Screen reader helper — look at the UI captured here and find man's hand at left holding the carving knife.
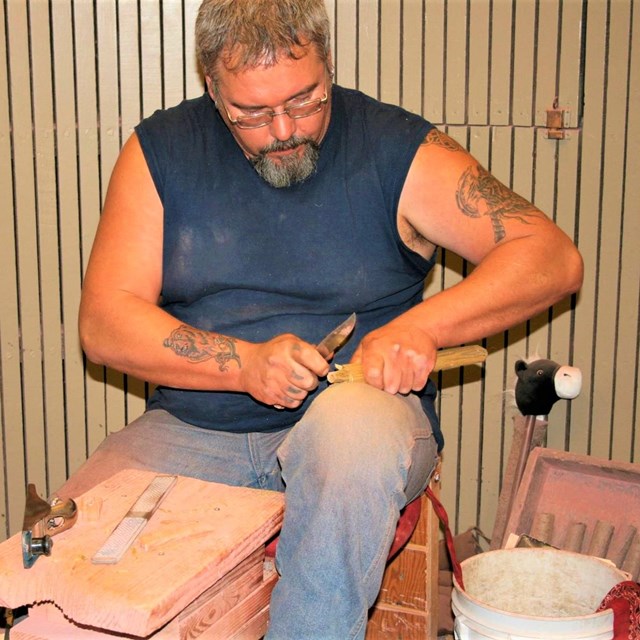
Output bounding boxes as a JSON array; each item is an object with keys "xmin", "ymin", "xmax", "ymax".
[{"xmin": 240, "ymin": 334, "xmax": 329, "ymax": 409}]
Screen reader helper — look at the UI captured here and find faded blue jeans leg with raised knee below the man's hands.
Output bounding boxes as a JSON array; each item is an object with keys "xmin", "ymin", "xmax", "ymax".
[{"xmin": 267, "ymin": 383, "xmax": 437, "ymax": 640}]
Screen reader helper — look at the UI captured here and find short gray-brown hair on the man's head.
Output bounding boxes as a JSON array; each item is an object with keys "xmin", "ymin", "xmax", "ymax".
[{"xmin": 195, "ymin": 0, "xmax": 331, "ymax": 77}]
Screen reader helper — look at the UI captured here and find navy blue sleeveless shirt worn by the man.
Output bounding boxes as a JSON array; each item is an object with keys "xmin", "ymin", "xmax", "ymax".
[{"xmin": 136, "ymin": 86, "xmax": 443, "ymax": 447}]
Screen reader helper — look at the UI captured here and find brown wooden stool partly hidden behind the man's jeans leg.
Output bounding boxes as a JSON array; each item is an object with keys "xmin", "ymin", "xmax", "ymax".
[{"xmin": 366, "ymin": 471, "xmax": 440, "ymax": 640}]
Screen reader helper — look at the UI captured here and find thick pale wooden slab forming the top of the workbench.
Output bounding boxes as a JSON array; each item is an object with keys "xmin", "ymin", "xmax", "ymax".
[{"xmin": 0, "ymin": 470, "xmax": 284, "ymax": 637}]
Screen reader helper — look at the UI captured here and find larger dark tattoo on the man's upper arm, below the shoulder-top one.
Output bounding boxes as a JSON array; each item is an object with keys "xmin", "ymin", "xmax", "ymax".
[{"xmin": 456, "ymin": 164, "xmax": 541, "ymax": 243}]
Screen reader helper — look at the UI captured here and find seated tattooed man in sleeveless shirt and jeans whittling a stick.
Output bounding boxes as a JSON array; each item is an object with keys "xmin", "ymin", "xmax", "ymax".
[{"xmin": 70, "ymin": 0, "xmax": 582, "ymax": 640}]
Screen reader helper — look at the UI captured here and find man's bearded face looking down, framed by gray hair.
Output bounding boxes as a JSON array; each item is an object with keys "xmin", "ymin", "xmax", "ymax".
[{"xmin": 207, "ymin": 47, "xmax": 331, "ymax": 187}]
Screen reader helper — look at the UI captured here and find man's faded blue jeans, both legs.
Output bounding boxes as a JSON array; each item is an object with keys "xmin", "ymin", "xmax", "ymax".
[{"xmin": 58, "ymin": 383, "xmax": 437, "ymax": 640}]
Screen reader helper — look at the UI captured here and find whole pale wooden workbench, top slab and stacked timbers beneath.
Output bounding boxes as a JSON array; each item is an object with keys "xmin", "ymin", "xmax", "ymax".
[{"xmin": 0, "ymin": 470, "xmax": 284, "ymax": 640}]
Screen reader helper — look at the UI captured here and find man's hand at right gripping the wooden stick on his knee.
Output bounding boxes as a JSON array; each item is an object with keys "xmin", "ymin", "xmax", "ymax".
[{"xmin": 351, "ymin": 318, "xmax": 437, "ymax": 393}]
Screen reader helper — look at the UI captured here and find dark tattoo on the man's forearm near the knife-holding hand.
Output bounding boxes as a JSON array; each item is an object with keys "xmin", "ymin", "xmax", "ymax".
[{"xmin": 162, "ymin": 324, "xmax": 242, "ymax": 371}]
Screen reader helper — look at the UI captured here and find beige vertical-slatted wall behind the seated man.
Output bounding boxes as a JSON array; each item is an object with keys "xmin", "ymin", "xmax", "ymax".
[{"xmin": 0, "ymin": 0, "xmax": 640, "ymax": 538}]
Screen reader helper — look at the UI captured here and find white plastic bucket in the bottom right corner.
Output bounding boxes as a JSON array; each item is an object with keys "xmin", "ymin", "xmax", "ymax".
[{"xmin": 452, "ymin": 549, "xmax": 628, "ymax": 640}]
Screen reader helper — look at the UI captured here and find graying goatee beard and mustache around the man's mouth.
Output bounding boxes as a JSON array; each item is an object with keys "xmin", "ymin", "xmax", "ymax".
[{"xmin": 251, "ymin": 136, "xmax": 320, "ymax": 189}]
